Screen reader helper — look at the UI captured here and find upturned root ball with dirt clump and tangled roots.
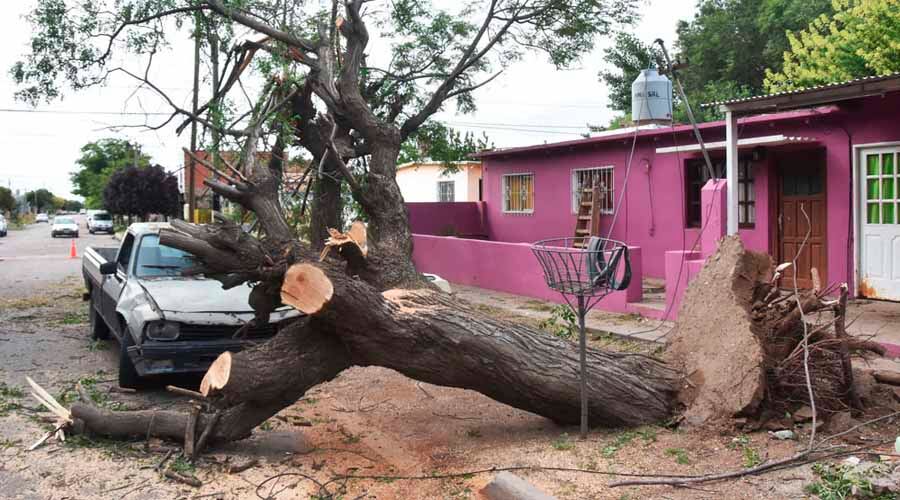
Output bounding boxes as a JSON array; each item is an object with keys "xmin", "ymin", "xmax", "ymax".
[{"xmin": 668, "ymin": 236, "xmax": 884, "ymax": 426}]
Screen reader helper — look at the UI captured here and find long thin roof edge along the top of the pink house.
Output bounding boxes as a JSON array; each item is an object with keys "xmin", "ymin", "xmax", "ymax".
[{"xmin": 472, "ymin": 106, "xmax": 838, "ymax": 159}]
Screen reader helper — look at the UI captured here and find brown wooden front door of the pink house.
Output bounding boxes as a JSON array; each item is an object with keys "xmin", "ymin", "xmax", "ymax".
[{"xmin": 776, "ymin": 153, "xmax": 828, "ymax": 288}]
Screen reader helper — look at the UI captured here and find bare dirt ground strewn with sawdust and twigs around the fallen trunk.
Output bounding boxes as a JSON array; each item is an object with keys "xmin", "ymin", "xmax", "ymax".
[{"xmin": 0, "ymin": 280, "xmax": 898, "ymax": 500}]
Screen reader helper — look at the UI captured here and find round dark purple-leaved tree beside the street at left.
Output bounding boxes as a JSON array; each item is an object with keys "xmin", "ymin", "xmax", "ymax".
[{"xmin": 103, "ymin": 165, "xmax": 181, "ymax": 219}]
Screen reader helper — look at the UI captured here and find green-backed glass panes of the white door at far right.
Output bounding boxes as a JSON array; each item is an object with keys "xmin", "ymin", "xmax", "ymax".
[{"xmin": 866, "ymin": 151, "xmax": 900, "ymax": 224}]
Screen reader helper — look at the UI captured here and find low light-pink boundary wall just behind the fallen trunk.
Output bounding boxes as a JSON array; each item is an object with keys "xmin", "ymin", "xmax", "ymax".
[{"xmin": 413, "ymin": 234, "xmax": 663, "ymax": 318}]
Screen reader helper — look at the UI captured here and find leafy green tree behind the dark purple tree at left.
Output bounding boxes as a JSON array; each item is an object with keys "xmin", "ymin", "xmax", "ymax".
[{"xmin": 71, "ymin": 139, "xmax": 150, "ymax": 209}]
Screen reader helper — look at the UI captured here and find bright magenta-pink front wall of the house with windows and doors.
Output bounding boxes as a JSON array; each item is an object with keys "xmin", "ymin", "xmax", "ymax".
[{"xmin": 482, "ymin": 93, "xmax": 900, "ymax": 290}]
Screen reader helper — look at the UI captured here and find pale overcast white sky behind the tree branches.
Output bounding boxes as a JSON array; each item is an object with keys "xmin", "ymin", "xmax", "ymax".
[{"xmin": 0, "ymin": 0, "xmax": 696, "ymax": 199}]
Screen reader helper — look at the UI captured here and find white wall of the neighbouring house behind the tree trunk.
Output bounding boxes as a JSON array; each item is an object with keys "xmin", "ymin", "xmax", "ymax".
[{"xmin": 397, "ymin": 162, "xmax": 481, "ymax": 203}]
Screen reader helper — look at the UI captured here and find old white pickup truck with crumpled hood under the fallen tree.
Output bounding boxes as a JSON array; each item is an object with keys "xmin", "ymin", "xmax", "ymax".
[{"xmin": 82, "ymin": 223, "xmax": 301, "ymax": 388}]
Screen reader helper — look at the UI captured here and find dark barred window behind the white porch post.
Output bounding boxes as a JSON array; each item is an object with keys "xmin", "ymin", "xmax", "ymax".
[{"xmin": 685, "ymin": 158, "xmax": 756, "ymax": 228}]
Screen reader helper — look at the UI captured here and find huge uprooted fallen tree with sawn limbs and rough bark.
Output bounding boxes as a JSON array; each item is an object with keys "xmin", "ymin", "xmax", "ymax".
[{"xmin": 20, "ymin": 0, "xmax": 896, "ymax": 453}]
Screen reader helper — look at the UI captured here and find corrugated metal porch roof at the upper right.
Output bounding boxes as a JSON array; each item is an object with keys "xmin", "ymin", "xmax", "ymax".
[{"xmin": 701, "ymin": 72, "xmax": 900, "ymax": 113}]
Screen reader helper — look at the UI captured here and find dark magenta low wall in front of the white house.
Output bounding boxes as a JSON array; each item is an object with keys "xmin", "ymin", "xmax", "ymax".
[{"xmin": 406, "ymin": 201, "xmax": 487, "ymax": 237}]
